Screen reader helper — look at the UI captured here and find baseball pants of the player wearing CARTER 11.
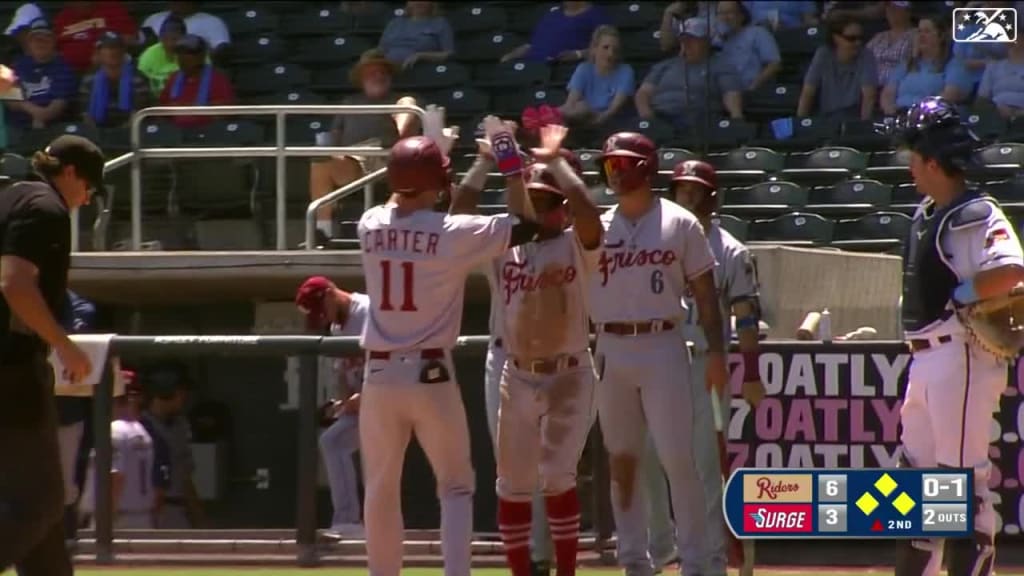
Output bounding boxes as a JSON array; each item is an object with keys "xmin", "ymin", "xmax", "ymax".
[{"xmin": 359, "ymin": 351, "xmax": 475, "ymax": 576}]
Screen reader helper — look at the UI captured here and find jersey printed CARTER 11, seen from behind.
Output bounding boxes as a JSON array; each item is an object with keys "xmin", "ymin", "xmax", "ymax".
[{"xmin": 358, "ymin": 204, "xmax": 518, "ymax": 352}]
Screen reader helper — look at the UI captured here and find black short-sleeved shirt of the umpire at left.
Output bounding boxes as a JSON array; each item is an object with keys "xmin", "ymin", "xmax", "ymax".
[{"xmin": 0, "ymin": 179, "xmax": 71, "ymax": 362}]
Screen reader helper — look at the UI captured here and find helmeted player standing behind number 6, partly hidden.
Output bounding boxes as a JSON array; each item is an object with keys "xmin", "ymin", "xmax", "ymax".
[{"xmin": 672, "ymin": 160, "xmax": 765, "ymax": 576}]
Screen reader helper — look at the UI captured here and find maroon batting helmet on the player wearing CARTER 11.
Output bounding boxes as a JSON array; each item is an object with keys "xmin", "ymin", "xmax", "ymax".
[{"xmin": 387, "ymin": 136, "xmax": 451, "ymax": 196}]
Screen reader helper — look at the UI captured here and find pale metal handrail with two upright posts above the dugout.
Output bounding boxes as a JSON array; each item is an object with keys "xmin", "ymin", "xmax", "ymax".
[{"xmin": 130, "ymin": 105, "xmax": 426, "ymax": 250}]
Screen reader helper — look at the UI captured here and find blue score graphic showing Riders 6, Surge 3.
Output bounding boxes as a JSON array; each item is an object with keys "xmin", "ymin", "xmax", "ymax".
[{"xmin": 723, "ymin": 468, "xmax": 974, "ymax": 539}]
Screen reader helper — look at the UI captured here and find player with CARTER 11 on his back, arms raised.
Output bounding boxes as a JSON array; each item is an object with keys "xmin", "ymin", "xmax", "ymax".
[{"xmin": 358, "ymin": 131, "xmax": 542, "ymax": 576}]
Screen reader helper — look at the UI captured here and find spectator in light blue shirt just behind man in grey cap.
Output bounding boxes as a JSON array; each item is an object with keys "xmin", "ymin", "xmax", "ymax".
[{"xmin": 718, "ymin": 1, "xmax": 782, "ymax": 90}]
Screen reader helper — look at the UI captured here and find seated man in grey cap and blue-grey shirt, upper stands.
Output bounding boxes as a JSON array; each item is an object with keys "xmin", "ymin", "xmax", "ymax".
[{"xmin": 636, "ymin": 17, "xmax": 743, "ymax": 127}]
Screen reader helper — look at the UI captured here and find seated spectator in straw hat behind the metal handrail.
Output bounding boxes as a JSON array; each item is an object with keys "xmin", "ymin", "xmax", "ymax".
[{"xmin": 309, "ymin": 48, "xmax": 418, "ymax": 245}]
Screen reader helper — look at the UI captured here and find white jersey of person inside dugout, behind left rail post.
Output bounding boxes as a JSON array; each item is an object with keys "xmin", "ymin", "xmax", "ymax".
[{"xmin": 82, "ymin": 420, "xmax": 157, "ymax": 513}]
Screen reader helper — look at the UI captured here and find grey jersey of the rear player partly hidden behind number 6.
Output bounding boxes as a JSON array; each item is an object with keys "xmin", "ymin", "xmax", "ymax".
[{"xmin": 683, "ymin": 222, "xmax": 758, "ymax": 351}]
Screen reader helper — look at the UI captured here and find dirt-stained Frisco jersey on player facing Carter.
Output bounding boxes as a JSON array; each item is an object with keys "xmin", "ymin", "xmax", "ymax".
[{"xmin": 490, "ymin": 229, "xmax": 600, "ymax": 359}]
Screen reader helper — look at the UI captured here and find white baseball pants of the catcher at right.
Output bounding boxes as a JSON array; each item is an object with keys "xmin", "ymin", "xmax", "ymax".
[{"xmin": 900, "ymin": 335, "xmax": 1008, "ymax": 576}]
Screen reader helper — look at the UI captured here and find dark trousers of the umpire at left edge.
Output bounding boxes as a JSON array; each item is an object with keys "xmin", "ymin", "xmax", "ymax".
[{"xmin": 0, "ymin": 356, "xmax": 72, "ymax": 576}]
